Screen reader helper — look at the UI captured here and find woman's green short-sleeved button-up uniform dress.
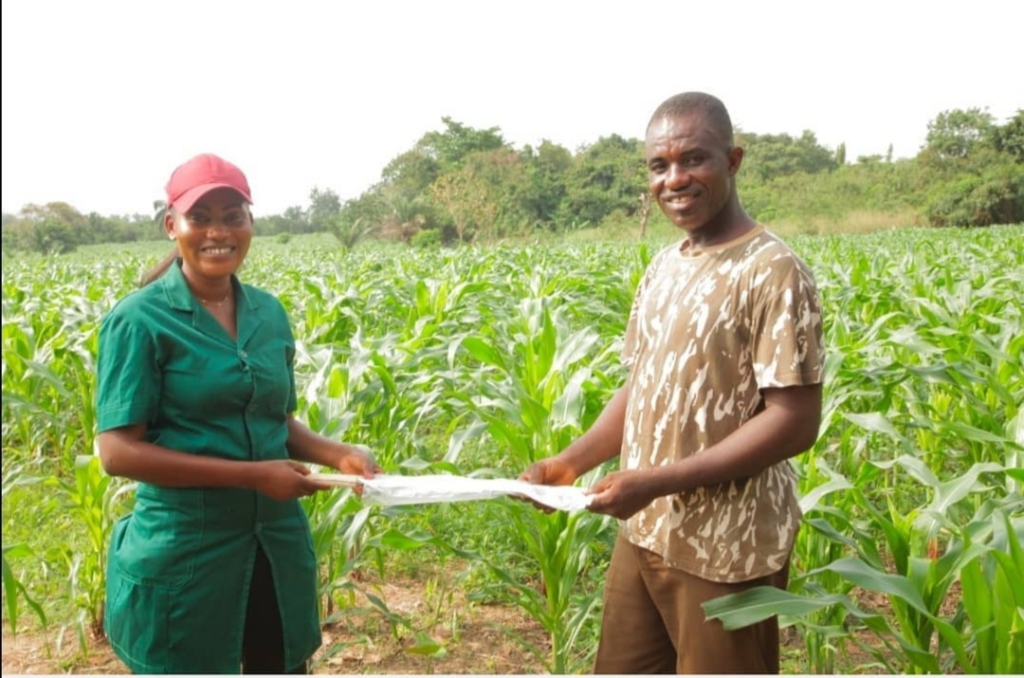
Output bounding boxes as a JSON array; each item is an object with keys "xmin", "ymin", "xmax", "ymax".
[{"xmin": 97, "ymin": 262, "xmax": 322, "ymax": 674}]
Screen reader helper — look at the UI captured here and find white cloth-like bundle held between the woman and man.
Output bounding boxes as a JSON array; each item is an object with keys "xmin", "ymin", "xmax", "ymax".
[{"xmin": 311, "ymin": 473, "xmax": 590, "ymax": 512}]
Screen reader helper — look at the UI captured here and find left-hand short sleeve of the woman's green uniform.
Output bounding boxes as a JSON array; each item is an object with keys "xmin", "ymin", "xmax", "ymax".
[{"xmin": 96, "ymin": 308, "xmax": 161, "ymax": 432}]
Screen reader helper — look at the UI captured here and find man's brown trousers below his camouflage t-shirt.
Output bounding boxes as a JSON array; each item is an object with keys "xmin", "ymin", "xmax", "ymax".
[{"xmin": 594, "ymin": 536, "xmax": 788, "ymax": 674}]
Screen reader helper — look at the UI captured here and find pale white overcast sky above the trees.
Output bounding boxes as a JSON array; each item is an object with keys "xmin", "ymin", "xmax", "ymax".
[{"xmin": 2, "ymin": 0, "xmax": 1024, "ymax": 216}]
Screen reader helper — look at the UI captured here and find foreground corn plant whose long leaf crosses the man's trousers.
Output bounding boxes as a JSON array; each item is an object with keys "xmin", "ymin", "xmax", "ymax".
[{"xmin": 705, "ymin": 458, "xmax": 1024, "ymax": 673}]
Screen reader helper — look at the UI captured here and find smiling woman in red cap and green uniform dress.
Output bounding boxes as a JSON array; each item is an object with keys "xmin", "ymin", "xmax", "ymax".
[{"xmin": 97, "ymin": 155, "xmax": 380, "ymax": 673}]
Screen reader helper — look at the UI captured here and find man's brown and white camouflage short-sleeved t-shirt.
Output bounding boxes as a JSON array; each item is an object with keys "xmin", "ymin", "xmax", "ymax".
[{"xmin": 621, "ymin": 226, "xmax": 824, "ymax": 582}]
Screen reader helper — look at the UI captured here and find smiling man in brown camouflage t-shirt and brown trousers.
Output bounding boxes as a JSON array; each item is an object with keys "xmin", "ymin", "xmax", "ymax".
[{"xmin": 522, "ymin": 92, "xmax": 823, "ymax": 674}]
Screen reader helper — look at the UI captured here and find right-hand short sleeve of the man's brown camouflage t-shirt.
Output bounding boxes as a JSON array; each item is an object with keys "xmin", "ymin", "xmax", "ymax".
[{"xmin": 752, "ymin": 258, "xmax": 824, "ymax": 388}]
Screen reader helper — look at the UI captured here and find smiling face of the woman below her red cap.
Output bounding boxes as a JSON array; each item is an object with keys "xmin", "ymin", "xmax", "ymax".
[{"xmin": 164, "ymin": 188, "xmax": 253, "ymax": 283}]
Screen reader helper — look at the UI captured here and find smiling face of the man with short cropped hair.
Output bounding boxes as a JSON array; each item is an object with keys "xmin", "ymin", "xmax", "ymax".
[{"xmin": 645, "ymin": 113, "xmax": 743, "ymax": 234}]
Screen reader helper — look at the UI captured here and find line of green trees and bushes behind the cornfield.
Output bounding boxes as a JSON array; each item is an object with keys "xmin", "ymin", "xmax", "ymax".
[{"xmin": 3, "ymin": 109, "xmax": 1024, "ymax": 253}]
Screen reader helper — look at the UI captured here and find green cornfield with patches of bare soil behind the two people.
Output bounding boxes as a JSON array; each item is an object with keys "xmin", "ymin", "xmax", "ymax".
[{"xmin": 2, "ymin": 225, "xmax": 1024, "ymax": 674}]
